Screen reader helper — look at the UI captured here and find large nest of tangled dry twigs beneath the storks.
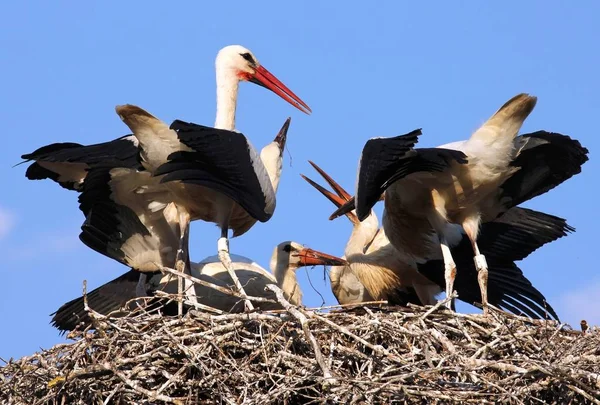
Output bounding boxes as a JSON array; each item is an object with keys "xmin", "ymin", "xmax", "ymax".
[{"xmin": 0, "ymin": 287, "xmax": 600, "ymax": 405}]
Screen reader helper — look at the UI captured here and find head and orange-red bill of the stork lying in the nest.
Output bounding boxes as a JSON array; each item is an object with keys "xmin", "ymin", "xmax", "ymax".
[{"xmin": 271, "ymin": 241, "xmax": 348, "ymax": 270}]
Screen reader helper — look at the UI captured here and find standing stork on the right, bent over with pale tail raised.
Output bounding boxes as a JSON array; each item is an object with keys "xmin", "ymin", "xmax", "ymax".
[{"xmin": 332, "ymin": 94, "xmax": 587, "ymax": 311}]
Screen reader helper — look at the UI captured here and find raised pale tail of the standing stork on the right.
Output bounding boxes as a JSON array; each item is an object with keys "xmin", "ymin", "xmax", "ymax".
[{"xmin": 471, "ymin": 93, "xmax": 537, "ymax": 143}]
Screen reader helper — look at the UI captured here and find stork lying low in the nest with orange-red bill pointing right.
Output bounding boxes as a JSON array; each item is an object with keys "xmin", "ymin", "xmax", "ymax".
[{"xmin": 52, "ymin": 241, "xmax": 346, "ymax": 331}]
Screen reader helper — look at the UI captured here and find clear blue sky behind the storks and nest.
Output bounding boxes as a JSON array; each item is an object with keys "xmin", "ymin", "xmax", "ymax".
[{"xmin": 0, "ymin": 0, "xmax": 600, "ymax": 359}]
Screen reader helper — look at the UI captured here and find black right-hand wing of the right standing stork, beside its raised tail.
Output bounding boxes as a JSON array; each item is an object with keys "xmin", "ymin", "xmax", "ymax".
[{"xmin": 501, "ymin": 131, "xmax": 588, "ymax": 207}]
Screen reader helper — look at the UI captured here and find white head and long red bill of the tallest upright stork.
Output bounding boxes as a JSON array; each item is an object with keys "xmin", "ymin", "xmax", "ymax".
[{"xmin": 215, "ymin": 45, "xmax": 312, "ymax": 114}]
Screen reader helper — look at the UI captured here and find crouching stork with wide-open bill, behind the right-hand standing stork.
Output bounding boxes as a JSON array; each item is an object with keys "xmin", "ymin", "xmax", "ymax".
[{"xmin": 303, "ymin": 162, "xmax": 573, "ymax": 318}]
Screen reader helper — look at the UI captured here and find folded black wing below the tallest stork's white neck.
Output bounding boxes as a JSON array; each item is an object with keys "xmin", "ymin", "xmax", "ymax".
[{"xmin": 155, "ymin": 120, "xmax": 274, "ymax": 222}]
